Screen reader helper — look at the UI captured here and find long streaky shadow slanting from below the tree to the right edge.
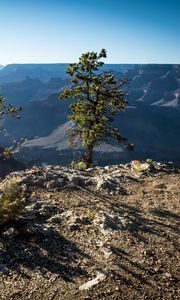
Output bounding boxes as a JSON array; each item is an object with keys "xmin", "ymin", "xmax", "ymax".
[{"xmin": 83, "ymin": 189, "xmax": 180, "ymax": 243}]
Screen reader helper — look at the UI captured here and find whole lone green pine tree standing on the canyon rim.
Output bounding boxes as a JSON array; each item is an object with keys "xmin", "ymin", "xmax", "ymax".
[{"xmin": 60, "ymin": 49, "xmax": 133, "ymax": 167}]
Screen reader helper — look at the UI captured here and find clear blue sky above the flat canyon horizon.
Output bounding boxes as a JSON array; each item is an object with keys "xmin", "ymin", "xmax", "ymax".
[{"xmin": 0, "ymin": 0, "xmax": 180, "ymax": 65}]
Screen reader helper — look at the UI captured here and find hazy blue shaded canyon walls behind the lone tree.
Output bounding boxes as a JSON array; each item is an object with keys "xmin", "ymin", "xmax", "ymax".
[{"xmin": 0, "ymin": 64, "xmax": 180, "ymax": 165}]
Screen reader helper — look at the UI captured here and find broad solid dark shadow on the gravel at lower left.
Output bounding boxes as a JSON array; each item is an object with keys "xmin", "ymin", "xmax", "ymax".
[{"xmin": 0, "ymin": 197, "xmax": 89, "ymax": 282}]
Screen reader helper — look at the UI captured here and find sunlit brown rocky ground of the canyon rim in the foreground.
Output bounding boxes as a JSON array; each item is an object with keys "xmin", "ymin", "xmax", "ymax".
[{"xmin": 0, "ymin": 162, "xmax": 180, "ymax": 300}]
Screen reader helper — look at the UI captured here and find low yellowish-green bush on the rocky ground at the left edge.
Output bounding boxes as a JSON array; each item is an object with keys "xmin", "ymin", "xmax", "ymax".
[{"xmin": 0, "ymin": 179, "xmax": 25, "ymax": 224}]
